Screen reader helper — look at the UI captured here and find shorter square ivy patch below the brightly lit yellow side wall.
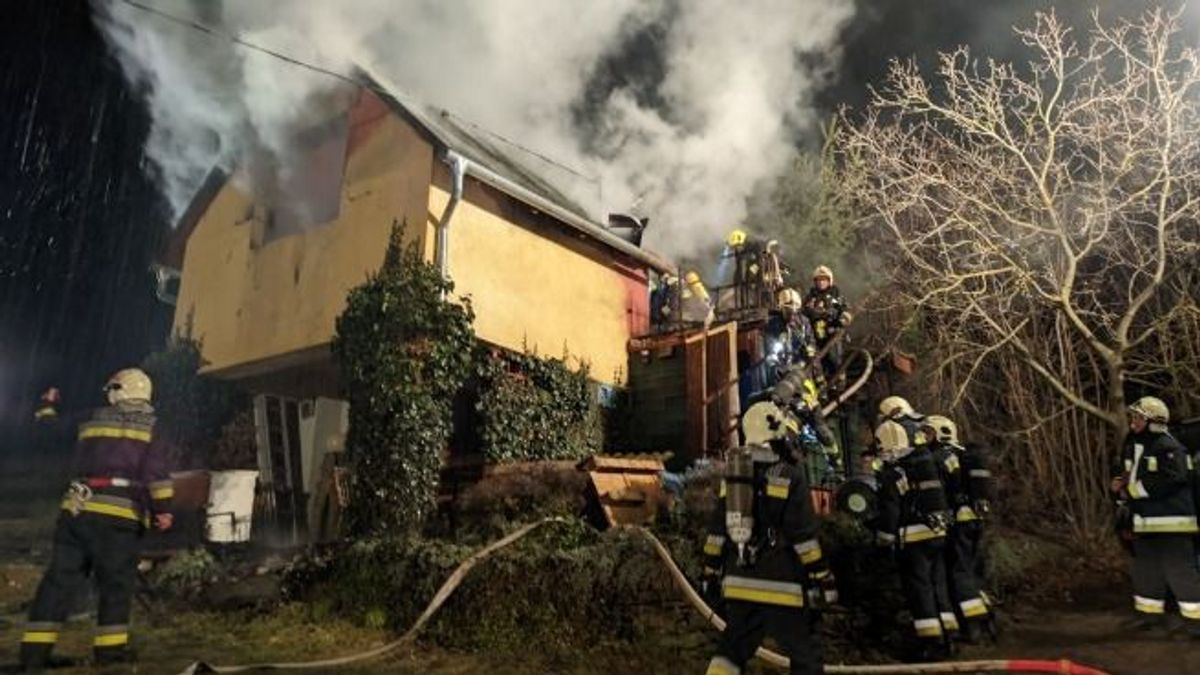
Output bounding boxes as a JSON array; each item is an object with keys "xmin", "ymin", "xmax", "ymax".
[{"xmin": 475, "ymin": 352, "xmax": 604, "ymax": 462}]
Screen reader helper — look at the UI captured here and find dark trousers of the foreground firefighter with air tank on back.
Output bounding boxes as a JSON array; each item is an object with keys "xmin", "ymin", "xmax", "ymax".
[{"xmin": 708, "ymin": 601, "xmax": 824, "ymax": 675}]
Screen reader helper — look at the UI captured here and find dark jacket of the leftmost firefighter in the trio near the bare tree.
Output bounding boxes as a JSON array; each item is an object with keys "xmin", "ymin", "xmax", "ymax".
[{"xmin": 875, "ymin": 447, "xmax": 949, "ymax": 546}]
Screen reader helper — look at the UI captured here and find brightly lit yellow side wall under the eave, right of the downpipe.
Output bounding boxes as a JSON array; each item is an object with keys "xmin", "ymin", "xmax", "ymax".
[{"xmin": 428, "ymin": 178, "xmax": 631, "ymax": 384}]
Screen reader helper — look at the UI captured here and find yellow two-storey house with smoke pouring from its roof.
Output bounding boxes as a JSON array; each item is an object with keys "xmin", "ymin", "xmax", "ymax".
[{"xmin": 161, "ymin": 72, "xmax": 671, "ymax": 535}]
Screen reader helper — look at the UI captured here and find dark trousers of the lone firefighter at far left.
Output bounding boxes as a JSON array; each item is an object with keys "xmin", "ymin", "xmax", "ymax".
[{"xmin": 20, "ymin": 513, "xmax": 142, "ymax": 668}]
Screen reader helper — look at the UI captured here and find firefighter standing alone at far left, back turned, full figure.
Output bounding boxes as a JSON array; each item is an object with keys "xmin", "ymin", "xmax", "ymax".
[{"xmin": 20, "ymin": 369, "xmax": 174, "ymax": 671}]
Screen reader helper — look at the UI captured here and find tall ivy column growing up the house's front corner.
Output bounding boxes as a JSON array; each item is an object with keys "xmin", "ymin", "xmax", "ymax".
[{"xmin": 332, "ymin": 227, "xmax": 475, "ymax": 534}]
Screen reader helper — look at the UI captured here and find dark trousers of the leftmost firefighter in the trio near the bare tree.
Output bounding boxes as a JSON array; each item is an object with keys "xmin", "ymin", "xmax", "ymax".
[{"xmin": 900, "ymin": 538, "xmax": 959, "ymax": 643}]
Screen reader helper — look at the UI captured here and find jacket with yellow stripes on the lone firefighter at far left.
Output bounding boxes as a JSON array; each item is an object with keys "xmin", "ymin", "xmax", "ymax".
[{"xmin": 62, "ymin": 401, "xmax": 175, "ymax": 525}]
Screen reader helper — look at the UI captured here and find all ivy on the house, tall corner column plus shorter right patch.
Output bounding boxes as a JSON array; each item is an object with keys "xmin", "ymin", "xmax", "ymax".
[{"xmin": 332, "ymin": 223, "xmax": 605, "ymax": 534}]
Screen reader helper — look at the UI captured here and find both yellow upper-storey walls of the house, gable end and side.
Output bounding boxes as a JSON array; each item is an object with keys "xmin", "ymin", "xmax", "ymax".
[{"xmin": 175, "ymin": 97, "xmax": 644, "ymax": 386}]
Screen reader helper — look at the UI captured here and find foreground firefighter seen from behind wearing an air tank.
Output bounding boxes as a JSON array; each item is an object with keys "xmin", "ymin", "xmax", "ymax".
[{"xmin": 702, "ymin": 423, "xmax": 838, "ymax": 675}]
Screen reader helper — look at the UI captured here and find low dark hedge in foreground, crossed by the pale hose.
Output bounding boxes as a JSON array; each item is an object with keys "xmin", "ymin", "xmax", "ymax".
[{"xmin": 289, "ymin": 520, "xmax": 701, "ymax": 656}]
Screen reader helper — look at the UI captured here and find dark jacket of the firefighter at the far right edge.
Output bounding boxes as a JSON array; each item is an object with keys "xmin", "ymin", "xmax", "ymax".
[{"xmin": 1121, "ymin": 430, "xmax": 1200, "ymax": 534}]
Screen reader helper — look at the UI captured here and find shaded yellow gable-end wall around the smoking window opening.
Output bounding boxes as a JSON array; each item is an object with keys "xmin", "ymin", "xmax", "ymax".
[{"xmin": 174, "ymin": 110, "xmax": 433, "ymax": 371}]
